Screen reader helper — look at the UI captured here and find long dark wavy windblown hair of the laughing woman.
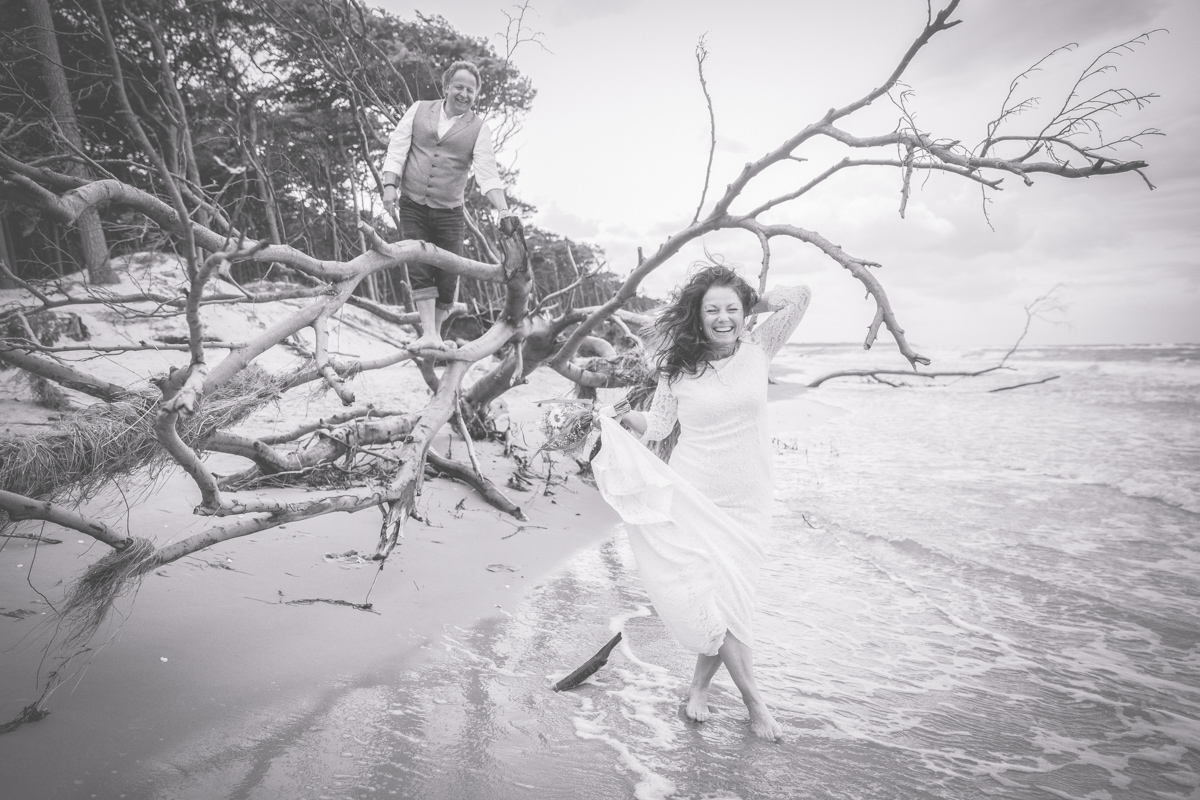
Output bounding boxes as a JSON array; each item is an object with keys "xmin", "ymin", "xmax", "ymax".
[{"xmin": 654, "ymin": 261, "xmax": 758, "ymax": 381}]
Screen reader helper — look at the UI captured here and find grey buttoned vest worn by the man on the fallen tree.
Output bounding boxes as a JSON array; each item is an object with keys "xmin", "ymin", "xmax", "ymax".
[{"xmin": 400, "ymin": 100, "xmax": 484, "ymax": 209}]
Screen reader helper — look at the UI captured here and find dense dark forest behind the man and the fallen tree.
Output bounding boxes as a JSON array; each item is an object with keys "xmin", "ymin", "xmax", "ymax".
[{"xmin": 0, "ymin": 0, "xmax": 638, "ymax": 318}]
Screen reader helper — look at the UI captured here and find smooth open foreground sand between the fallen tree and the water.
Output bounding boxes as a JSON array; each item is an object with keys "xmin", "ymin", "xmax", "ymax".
[{"xmin": 0, "ymin": 386, "xmax": 617, "ymax": 798}]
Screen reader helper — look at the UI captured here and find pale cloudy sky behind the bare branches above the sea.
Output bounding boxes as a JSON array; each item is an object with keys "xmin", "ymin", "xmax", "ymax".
[{"xmin": 382, "ymin": 0, "xmax": 1200, "ymax": 347}]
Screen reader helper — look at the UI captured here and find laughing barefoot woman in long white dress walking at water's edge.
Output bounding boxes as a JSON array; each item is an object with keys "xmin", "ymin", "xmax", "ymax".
[{"xmin": 593, "ymin": 265, "xmax": 810, "ymax": 740}]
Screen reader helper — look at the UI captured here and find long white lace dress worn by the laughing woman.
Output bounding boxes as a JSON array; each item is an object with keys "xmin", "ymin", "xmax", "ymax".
[{"xmin": 592, "ymin": 287, "xmax": 811, "ymax": 655}]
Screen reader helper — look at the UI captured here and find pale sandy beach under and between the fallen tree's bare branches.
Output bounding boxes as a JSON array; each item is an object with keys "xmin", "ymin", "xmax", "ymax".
[{"xmin": 0, "ymin": 263, "xmax": 616, "ymax": 798}]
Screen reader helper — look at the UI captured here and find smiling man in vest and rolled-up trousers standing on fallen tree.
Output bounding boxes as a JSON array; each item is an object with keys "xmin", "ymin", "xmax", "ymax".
[{"xmin": 383, "ymin": 61, "xmax": 514, "ymax": 350}]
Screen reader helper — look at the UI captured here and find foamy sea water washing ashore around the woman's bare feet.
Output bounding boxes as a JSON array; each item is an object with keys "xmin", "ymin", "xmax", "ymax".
[{"xmin": 218, "ymin": 345, "xmax": 1200, "ymax": 800}]
